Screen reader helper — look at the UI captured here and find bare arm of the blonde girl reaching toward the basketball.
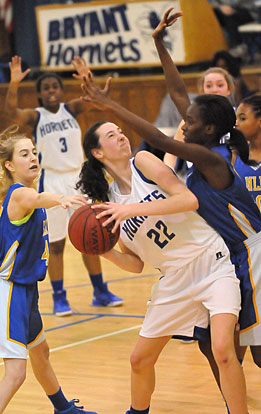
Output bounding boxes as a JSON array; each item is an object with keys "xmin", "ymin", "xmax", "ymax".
[{"xmin": 8, "ymin": 187, "xmax": 87, "ymax": 220}]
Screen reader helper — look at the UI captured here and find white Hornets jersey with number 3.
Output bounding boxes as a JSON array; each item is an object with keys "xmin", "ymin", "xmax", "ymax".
[{"xmin": 33, "ymin": 103, "xmax": 83, "ymax": 172}]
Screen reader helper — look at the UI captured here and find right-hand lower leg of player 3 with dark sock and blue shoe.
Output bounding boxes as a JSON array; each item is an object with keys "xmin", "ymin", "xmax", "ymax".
[{"xmin": 82, "ymin": 254, "xmax": 123, "ymax": 306}]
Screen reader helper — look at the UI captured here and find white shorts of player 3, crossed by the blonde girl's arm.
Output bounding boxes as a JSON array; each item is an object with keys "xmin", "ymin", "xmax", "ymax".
[{"xmin": 39, "ymin": 170, "xmax": 81, "ymax": 243}]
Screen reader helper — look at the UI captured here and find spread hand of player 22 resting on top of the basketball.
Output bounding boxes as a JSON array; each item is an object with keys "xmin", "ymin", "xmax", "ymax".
[{"xmin": 92, "ymin": 201, "xmax": 132, "ymax": 233}]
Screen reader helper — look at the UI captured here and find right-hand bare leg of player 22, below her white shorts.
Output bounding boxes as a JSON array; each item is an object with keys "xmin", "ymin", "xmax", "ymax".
[{"xmin": 210, "ymin": 313, "xmax": 247, "ymax": 414}]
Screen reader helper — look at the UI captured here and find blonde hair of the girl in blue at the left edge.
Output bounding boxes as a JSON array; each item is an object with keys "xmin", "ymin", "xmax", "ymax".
[{"xmin": 0, "ymin": 125, "xmax": 30, "ymax": 203}]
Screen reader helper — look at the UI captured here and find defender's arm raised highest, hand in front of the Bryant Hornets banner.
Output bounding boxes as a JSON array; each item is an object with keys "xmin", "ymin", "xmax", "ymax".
[{"xmin": 152, "ymin": 7, "xmax": 190, "ymax": 119}]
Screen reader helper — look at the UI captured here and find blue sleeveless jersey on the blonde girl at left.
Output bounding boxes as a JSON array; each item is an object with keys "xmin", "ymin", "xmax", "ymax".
[{"xmin": 0, "ymin": 184, "xmax": 49, "ymax": 284}]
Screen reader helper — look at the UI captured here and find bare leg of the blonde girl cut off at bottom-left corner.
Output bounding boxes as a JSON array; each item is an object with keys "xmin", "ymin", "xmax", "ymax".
[{"xmin": 0, "ymin": 358, "xmax": 26, "ymax": 413}]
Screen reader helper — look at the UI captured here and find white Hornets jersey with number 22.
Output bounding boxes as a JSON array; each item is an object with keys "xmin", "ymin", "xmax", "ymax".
[{"xmin": 109, "ymin": 159, "xmax": 221, "ymax": 275}]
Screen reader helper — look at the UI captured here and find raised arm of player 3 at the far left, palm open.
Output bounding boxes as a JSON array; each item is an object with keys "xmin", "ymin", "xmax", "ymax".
[{"xmin": 4, "ymin": 56, "xmax": 37, "ymax": 128}]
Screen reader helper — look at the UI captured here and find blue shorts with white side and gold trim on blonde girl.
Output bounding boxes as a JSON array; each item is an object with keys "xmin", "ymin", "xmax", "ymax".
[{"xmin": 0, "ymin": 278, "xmax": 45, "ymax": 359}]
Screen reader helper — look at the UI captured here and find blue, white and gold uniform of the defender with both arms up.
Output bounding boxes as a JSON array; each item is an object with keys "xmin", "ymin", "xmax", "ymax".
[{"xmin": 187, "ymin": 144, "xmax": 261, "ymax": 332}]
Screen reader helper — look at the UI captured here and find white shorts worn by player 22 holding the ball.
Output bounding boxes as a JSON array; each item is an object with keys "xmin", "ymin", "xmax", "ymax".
[{"xmin": 140, "ymin": 239, "xmax": 241, "ymax": 339}]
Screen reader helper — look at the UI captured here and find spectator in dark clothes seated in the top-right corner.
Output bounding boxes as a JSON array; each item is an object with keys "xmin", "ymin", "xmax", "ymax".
[{"xmin": 208, "ymin": 0, "xmax": 258, "ymax": 57}]
